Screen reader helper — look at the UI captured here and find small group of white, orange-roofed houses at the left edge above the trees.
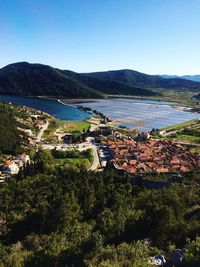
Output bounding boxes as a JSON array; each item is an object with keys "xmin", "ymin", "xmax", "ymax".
[{"xmin": 0, "ymin": 153, "xmax": 30, "ymax": 181}]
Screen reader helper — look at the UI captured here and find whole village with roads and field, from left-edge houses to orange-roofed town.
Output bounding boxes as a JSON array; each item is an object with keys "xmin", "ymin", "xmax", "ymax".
[{"xmin": 0, "ymin": 102, "xmax": 200, "ymax": 182}]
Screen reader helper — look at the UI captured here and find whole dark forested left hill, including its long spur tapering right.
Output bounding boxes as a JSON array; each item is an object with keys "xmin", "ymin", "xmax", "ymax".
[{"xmin": 0, "ymin": 62, "xmax": 156, "ymax": 98}]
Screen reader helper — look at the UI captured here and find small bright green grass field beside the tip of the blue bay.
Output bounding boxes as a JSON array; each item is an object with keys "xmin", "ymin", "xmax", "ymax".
[{"xmin": 63, "ymin": 121, "xmax": 90, "ymax": 133}]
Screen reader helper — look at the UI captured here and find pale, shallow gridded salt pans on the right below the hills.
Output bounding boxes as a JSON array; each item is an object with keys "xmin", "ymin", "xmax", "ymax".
[{"xmin": 81, "ymin": 98, "xmax": 200, "ymax": 131}]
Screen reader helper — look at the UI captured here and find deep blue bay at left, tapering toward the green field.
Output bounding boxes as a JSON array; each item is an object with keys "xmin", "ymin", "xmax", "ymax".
[{"xmin": 0, "ymin": 95, "xmax": 91, "ymax": 120}]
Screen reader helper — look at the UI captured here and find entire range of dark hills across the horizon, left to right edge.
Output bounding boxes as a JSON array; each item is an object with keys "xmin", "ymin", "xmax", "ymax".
[{"xmin": 0, "ymin": 62, "xmax": 200, "ymax": 98}]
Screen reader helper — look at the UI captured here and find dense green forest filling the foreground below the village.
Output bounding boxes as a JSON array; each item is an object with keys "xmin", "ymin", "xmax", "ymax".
[{"xmin": 0, "ymin": 157, "xmax": 200, "ymax": 267}]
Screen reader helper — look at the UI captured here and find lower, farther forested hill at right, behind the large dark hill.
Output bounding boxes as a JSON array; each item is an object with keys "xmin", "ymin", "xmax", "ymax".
[{"xmin": 84, "ymin": 69, "xmax": 200, "ymax": 91}]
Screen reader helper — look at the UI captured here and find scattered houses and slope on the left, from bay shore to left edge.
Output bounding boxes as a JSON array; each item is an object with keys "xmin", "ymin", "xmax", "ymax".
[{"xmin": 0, "ymin": 103, "xmax": 50, "ymax": 183}]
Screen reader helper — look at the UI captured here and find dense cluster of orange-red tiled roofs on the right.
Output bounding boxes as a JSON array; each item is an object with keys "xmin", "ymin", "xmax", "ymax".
[{"xmin": 104, "ymin": 139, "xmax": 200, "ymax": 173}]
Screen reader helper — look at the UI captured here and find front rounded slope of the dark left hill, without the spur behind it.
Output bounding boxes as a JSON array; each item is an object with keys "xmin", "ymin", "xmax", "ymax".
[{"xmin": 0, "ymin": 62, "xmax": 102, "ymax": 97}]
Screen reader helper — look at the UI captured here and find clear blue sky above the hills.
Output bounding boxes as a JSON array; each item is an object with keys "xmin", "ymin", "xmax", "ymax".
[{"xmin": 0, "ymin": 0, "xmax": 200, "ymax": 75}]
